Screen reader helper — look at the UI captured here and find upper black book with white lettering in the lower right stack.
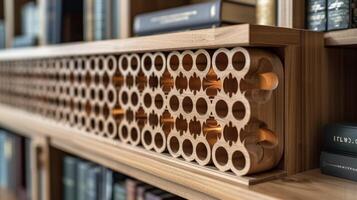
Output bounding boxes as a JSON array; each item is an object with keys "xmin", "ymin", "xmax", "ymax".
[{"xmin": 323, "ymin": 123, "xmax": 357, "ymax": 155}]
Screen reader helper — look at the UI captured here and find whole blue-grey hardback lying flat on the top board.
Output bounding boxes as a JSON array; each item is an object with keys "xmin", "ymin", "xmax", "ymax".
[{"xmin": 134, "ymin": 1, "xmax": 255, "ymax": 35}]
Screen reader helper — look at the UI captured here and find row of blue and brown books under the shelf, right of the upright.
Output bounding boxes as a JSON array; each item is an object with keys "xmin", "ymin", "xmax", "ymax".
[{"xmin": 62, "ymin": 155, "xmax": 182, "ymax": 200}]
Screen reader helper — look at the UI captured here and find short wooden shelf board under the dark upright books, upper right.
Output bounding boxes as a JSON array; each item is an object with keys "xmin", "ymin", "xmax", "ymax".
[{"xmin": 324, "ymin": 28, "xmax": 357, "ymax": 47}]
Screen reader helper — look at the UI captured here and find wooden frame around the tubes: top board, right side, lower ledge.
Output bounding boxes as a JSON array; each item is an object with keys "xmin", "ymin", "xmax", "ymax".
[{"xmin": 0, "ymin": 22, "xmax": 342, "ymax": 199}]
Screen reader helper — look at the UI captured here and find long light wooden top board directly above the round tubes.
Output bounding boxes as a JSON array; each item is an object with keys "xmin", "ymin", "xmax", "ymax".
[{"xmin": 0, "ymin": 24, "xmax": 300, "ymax": 60}]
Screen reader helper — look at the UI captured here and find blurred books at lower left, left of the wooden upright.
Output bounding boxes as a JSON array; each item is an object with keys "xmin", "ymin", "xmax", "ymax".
[{"xmin": 0, "ymin": 129, "xmax": 31, "ymax": 199}]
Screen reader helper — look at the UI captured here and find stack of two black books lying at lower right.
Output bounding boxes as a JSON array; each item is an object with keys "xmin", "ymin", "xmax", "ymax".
[{"xmin": 320, "ymin": 124, "xmax": 357, "ymax": 181}]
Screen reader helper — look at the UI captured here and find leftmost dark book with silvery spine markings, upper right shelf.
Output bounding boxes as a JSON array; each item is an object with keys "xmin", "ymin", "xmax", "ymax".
[{"xmin": 307, "ymin": 0, "xmax": 327, "ymax": 31}]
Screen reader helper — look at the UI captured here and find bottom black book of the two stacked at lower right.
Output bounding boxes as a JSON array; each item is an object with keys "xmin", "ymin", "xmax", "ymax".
[{"xmin": 320, "ymin": 151, "xmax": 357, "ymax": 181}]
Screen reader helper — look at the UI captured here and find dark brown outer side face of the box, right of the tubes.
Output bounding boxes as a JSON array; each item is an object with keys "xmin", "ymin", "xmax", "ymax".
[{"xmin": 301, "ymin": 32, "xmax": 329, "ymax": 170}]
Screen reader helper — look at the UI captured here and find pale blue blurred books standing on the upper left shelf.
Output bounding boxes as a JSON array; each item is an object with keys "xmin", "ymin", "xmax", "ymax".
[{"xmin": 12, "ymin": 1, "xmax": 39, "ymax": 47}]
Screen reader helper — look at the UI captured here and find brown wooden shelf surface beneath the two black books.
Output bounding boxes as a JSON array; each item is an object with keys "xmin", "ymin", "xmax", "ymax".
[{"xmin": 250, "ymin": 169, "xmax": 357, "ymax": 200}]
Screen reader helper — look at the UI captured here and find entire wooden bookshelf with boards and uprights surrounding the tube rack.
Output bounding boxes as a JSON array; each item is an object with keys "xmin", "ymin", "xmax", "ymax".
[{"xmin": 0, "ymin": 0, "xmax": 357, "ymax": 200}]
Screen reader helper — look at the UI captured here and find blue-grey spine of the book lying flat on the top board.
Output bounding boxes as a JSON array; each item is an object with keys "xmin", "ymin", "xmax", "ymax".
[{"xmin": 134, "ymin": 1, "xmax": 222, "ymax": 35}]
